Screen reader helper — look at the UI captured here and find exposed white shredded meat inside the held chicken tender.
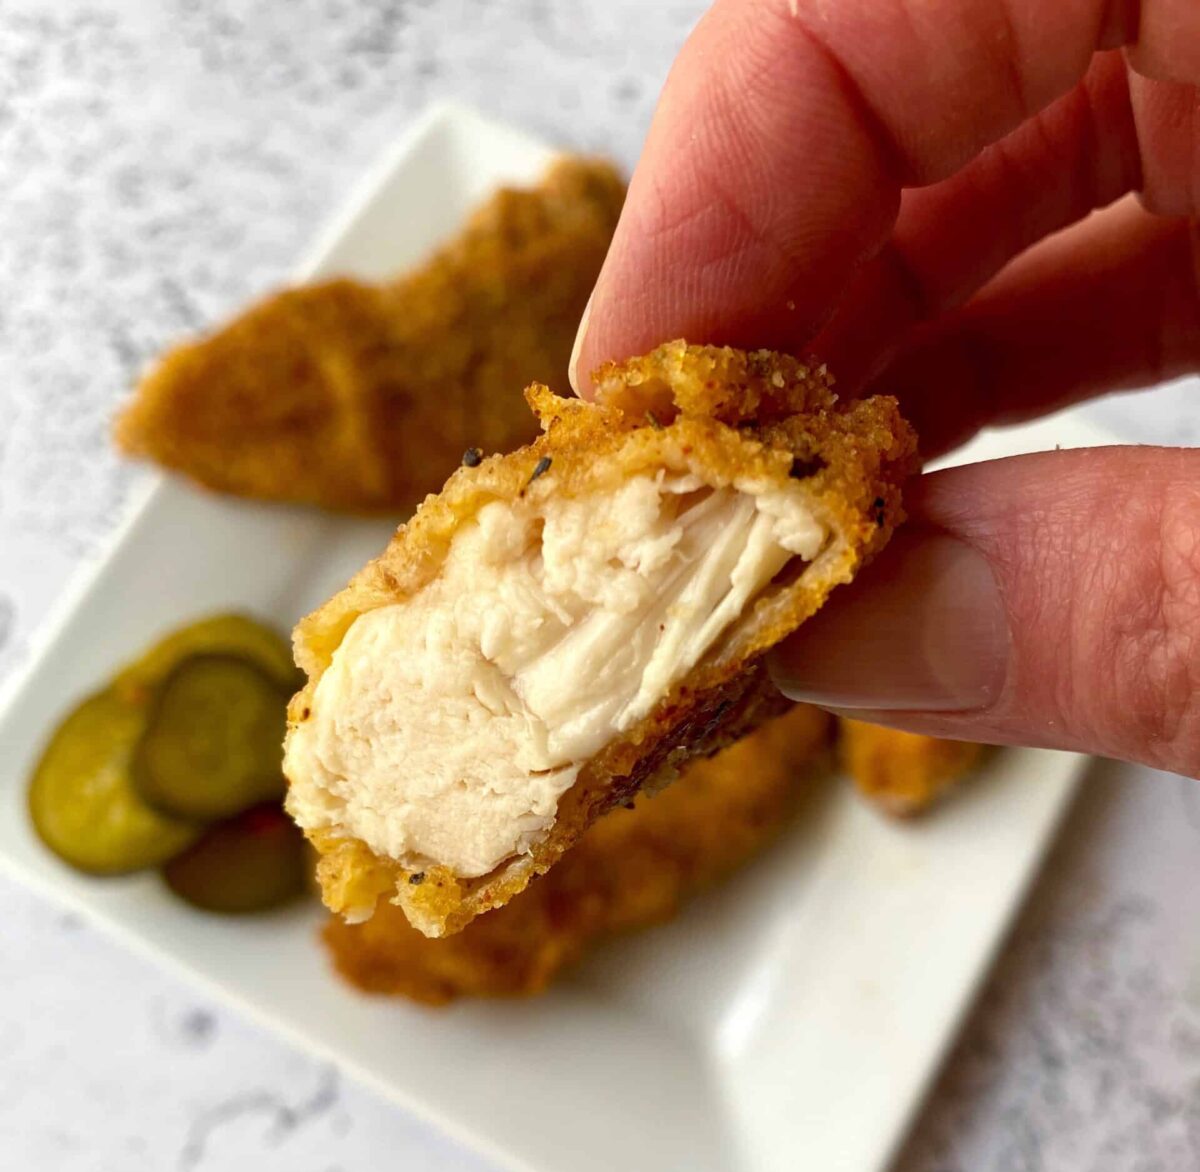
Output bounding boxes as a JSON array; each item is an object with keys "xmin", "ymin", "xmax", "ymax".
[{"xmin": 290, "ymin": 473, "xmax": 827, "ymax": 877}]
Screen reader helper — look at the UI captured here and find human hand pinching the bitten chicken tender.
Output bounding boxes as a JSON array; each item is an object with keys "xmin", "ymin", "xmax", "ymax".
[{"xmin": 572, "ymin": 0, "xmax": 1200, "ymax": 775}]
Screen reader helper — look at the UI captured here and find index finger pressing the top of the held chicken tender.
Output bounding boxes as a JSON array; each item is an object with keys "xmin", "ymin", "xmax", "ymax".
[{"xmin": 571, "ymin": 0, "xmax": 1132, "ymax": 390}]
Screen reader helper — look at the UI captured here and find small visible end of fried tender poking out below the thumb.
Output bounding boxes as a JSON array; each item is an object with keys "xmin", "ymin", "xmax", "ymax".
[{"xmin": 839, "ymin": 719, "xmax": 983, "ymax": 817}]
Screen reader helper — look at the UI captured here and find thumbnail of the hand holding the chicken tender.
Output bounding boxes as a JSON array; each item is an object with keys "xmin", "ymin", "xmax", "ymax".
[{"xmin": 772, "ymin": 534, "xmax": 1009, "ymax": 713}]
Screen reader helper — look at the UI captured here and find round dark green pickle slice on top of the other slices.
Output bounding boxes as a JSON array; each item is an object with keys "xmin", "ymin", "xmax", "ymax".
[{"xmin": 133, "ymin": 655, "xmax": 288, "ymax": 822}]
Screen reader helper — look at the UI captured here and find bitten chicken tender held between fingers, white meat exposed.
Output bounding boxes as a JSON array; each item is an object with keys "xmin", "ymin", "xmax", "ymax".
[{"xmin": 284, "ymin": 342, "xmax": 916, "ymax": 936}]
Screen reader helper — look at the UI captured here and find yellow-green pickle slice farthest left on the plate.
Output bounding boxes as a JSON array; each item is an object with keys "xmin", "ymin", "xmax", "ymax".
[{"xmin": 29, "ymin": 689, "xmax": 200, "ymax": 875}]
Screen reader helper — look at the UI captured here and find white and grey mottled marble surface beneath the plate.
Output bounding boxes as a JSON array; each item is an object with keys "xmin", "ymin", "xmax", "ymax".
[{"xmin": 0, "ymin": 0, "xmax": 1200, "ymax": 1172}]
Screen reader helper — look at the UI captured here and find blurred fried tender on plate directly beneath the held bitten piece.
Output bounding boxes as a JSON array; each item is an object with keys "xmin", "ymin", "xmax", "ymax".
[{"xmin": 324, "ymin": 705, "xmax": 832, "ymax": 1005}]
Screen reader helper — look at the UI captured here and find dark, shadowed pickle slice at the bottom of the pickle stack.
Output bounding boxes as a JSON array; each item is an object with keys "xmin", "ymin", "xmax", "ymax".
[{"xmin": 162, "ymin": 804, "xmax": 308, "ymax": 914}]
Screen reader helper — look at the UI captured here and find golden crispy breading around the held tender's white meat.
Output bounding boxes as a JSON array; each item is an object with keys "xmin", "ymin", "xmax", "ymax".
[{"xmin": 286, "ymin": 342, "xmax": 916, "ymax": 936}]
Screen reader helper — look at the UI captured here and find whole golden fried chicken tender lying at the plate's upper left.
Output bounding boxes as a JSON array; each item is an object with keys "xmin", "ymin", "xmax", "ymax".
[{"xmin": 115, "ymin": 157, "xmax": 625, "ymax": 512}]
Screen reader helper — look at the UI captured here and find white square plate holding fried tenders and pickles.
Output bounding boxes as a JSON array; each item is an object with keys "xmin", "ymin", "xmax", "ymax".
[{"xmin": 0, "ymin": 108, "xmax": 1106, "ymax": 1172}]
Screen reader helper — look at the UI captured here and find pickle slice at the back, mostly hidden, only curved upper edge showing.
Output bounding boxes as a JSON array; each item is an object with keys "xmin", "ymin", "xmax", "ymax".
[{"xmin": 113, "ymin": 614, "xmax": 304, "ymax": 699}]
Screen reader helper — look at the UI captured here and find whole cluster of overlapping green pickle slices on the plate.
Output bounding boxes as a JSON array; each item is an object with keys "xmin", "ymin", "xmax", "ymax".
[{"xmin": 29, "ymin": 614, "xmax": 308, "ymax": 913}]
